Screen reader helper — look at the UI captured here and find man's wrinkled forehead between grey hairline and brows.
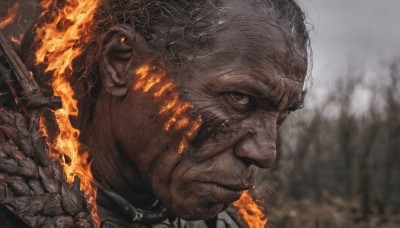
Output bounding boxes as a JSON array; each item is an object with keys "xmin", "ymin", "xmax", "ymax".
[{"xmin": 188, "ymin": 1, "xmax": 307, "ymax": 84}]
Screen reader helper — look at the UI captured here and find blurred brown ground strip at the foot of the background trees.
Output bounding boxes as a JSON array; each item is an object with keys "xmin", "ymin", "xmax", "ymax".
[{"xmin": 267, "ymin": 195, "xmax": 400, "ymax": 228}]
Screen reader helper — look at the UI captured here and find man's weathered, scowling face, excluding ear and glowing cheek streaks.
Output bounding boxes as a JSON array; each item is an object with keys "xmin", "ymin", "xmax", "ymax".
[{"xmin": 108, "ymin": 4, "xmax": 307, "ymax": 220}]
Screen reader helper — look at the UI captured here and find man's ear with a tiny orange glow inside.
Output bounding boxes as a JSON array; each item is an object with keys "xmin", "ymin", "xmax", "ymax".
[{"xmin": 99, "ymin": 25, "xmax": 149, "ymax": 97}]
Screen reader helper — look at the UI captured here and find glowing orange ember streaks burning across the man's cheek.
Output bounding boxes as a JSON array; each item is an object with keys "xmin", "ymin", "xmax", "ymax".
[{"xmin": 133, "ymin": 64, "xmax": 202, "ymax": 153}]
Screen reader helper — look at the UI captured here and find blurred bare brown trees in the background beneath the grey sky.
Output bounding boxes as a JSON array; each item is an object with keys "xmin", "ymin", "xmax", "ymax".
[{"xmin": 260, "ymin": 61, "xmax": 400, "ymax": 227}]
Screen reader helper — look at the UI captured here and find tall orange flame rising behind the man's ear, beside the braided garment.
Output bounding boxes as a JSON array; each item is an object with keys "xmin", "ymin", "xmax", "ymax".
[{"xmin": 35, "ymin": 0, "xmax": 100, "ymax": 227}]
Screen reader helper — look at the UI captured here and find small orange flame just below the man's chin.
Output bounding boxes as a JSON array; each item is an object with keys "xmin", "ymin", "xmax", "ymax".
[{"xmin": 234, "ymin": 191, "xmax": 268, "ymax": 228}]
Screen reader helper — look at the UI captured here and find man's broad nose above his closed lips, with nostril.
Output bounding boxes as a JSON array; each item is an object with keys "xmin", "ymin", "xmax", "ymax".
[{"xmin": 234, "ymin": 129, "xmax": 276, "ymax": 168}]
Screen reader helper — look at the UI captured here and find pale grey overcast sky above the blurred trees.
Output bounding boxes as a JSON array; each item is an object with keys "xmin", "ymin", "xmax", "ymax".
[{"xmin": 298, "ymin": 0, "xmax": 400, "ymax": 101}]
